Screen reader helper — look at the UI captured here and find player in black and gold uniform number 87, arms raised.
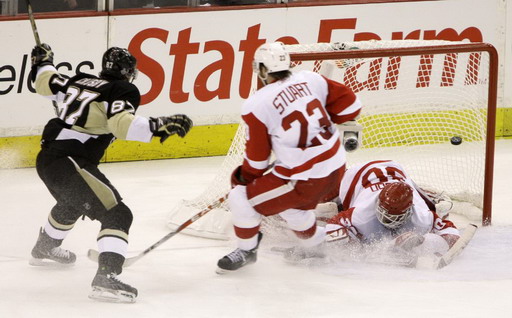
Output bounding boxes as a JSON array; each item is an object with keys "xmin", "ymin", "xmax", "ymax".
[{"xmin": 30, "ymin": 44, "xmax": 192, "ymax": 302}]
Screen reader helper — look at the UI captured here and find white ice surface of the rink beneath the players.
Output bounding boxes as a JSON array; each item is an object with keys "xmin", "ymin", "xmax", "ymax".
[{"xmin": 0, "ymin": 140, "xmax": 512, "ymax": 318}]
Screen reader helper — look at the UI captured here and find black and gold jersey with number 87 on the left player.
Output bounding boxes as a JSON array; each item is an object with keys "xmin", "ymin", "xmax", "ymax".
[{"xmin": 36, "ymin": 66, "xmax": 152, "ymax": 163}]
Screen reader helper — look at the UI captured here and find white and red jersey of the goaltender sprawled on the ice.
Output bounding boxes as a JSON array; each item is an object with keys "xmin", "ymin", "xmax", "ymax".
[{"xmin": 335, "ymin": 160, "xmax": 459, "ymax": 241}]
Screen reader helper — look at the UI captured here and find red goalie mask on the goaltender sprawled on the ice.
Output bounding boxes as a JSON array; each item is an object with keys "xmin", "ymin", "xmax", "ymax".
[{"xmin": 376, "ymin": 182, "xmax": 413, "ymax": 229}]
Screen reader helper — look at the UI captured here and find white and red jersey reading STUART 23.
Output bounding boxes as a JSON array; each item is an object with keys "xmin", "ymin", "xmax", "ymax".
[{"xmin": 242, "ymin": 71, "xmax": 361, "ymax": 181}]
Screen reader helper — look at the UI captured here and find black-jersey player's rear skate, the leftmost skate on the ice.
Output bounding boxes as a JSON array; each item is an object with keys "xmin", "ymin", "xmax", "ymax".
[{"xmin": 29, "ymin": 229, "xmax": 76, "ymax": 266}]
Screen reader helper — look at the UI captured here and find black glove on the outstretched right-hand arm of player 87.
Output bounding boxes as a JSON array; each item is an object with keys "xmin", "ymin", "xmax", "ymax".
[{"xmin": 149, "ymin": 114, "xmax": 193, "ymax": 143}]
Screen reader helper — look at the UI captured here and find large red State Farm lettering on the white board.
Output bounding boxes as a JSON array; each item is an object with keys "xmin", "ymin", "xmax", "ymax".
[{"xmin": 128, "ymin": 18, "xmax": 483, "ymax": 105}]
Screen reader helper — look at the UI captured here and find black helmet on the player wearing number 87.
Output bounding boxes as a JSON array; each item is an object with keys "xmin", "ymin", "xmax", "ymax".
[{"xmin": 100, "ymin": 46, "xmax": 137, "ymax": 82}]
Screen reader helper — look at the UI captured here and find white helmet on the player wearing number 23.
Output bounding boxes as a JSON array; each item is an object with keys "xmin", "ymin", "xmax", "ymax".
[{"xmin": 252, "ymin": 42, "xmax": 290, "ymax": 74}]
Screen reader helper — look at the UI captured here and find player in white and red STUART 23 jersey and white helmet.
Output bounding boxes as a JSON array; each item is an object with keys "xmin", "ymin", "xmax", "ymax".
[{"xmin": 217, "ymin": 42, "xmax": 361, "ymax": 272}]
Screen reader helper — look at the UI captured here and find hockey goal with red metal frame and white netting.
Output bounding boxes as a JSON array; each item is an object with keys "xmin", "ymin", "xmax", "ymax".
[{"xmin": 168, "ymin": 40, "xmax": 497, "ymax": 239}]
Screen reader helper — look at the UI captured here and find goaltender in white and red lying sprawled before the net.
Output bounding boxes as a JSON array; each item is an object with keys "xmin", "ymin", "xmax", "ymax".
[{"xmin": 327, "ymin": 160, "xmax": 459, "ymax": 255}]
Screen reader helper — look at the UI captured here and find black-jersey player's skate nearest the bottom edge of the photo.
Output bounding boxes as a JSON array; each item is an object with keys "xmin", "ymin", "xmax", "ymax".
[{"xmin": 89, "ymin": 273, "xmax": 137, "ymax": 303}]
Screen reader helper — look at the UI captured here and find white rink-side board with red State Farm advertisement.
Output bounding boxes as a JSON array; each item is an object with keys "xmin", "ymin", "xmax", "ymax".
[{"xmin": 0, "ymin": 0, "xmax": 510, "ymax": 135}]
